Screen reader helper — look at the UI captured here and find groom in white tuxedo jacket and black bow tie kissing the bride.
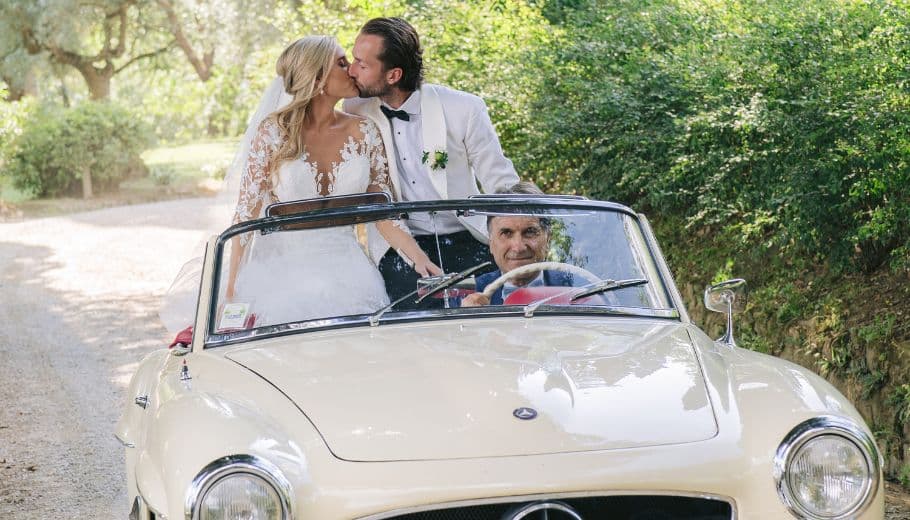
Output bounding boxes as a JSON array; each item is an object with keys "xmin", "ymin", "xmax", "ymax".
[{"xmin": 344, "ymin": 18, "xmax": 518, "ymax": 301}]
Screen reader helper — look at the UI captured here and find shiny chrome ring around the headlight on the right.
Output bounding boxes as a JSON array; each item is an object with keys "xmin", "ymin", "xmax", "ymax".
[{"xmin": 774, "ymin": 415, "xmax": 881, "ymax": 520}]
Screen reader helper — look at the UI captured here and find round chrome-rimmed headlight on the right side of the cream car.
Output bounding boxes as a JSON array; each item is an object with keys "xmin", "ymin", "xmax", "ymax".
[{"xmin": 775, "ymin": 417, "xmax": 879, "ymax": 520}]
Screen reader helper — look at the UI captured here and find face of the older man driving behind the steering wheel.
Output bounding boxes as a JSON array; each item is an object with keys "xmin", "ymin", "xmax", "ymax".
[{"xmin": 490, "ymin": 217, "xmax": 550, "ymax": 286}]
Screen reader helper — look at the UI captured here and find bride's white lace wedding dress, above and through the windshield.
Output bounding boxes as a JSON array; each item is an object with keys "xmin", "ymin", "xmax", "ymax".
[{"xmin": 225, "ymin": 120, "xmax": 391, "ymax": 327}]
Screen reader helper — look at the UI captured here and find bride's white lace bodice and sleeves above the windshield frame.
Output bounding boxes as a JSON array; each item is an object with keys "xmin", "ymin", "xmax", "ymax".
[{"xmin": 233, "ymin": 119, "xmax": 393, "ymax": 228}]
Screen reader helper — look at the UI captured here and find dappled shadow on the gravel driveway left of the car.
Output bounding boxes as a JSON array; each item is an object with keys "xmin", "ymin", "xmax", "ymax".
[{"xmin": 0, "ymin": 237, "xmax": 165, "ymax": 519}]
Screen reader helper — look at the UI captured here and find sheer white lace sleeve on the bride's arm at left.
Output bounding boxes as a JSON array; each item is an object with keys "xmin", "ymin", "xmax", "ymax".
[{"xmin": 233, "ymin": 119, "xmax": 280, "ymax": 237}]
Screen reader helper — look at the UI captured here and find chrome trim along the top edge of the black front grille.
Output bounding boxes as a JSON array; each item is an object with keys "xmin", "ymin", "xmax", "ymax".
[{"xmin": 356, "ymin": 490, "xmax": 739, "ymax": 520}]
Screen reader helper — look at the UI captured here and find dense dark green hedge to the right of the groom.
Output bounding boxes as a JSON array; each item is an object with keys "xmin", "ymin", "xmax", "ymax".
[{"xmin": 517, "ymin": 0, "xmax": 910, "ymax": 271}]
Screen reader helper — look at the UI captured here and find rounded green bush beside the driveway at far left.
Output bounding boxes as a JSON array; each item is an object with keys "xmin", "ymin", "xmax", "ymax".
[{"xmin": 5, "ymin": 103, "xmax": 152, "ymax": 197}]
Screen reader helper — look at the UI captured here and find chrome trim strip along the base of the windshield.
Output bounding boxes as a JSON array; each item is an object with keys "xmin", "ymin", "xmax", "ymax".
[{"xmin": 205, "ymin": 305, "xmax": 679, "ymax": 348}]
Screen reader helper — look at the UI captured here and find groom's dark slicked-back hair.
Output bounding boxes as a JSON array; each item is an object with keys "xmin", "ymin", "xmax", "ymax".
[{"xmin": 360, "ymin": 18, "xmax": 423, "ymax": 92}]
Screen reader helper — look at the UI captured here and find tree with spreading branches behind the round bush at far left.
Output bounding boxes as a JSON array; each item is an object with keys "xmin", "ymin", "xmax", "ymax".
[{"xmin": 0, "ymin": 0, "xmax": 172, "ymax": 100}]
